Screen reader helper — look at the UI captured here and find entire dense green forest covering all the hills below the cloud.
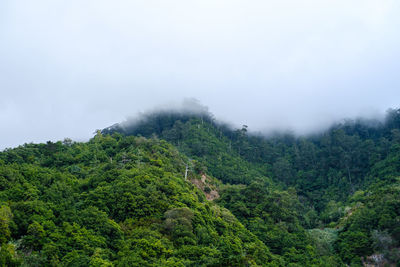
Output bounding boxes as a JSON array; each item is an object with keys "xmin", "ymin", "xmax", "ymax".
[{"xmin": 0, "ymin": 109, "xmax": 400, "ymax": 266}]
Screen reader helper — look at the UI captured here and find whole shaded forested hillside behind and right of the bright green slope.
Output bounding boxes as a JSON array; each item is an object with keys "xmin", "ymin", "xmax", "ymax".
[{"xmin": 103, "ymin": 109, "xmax": 400, "ymax": 265}]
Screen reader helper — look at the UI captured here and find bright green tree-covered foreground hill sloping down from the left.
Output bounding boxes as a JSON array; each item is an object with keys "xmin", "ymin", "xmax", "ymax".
[{"xmin": 0, "ymin": 133, "xmax": 276, "ymax": 266}]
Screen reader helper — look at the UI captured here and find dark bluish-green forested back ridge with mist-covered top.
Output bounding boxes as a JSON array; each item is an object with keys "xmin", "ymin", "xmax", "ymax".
[{"xmin": 103, "ymin": 107, "xmax": 400, "ymax": 211}]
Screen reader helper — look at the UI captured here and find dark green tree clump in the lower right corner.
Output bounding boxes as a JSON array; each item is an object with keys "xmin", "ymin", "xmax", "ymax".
[{"xmin": 336, "ymin": 178, "xmax": 400, "ymax": 262}]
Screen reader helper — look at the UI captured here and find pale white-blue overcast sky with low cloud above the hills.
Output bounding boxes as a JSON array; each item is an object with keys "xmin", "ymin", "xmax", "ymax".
[{"xmin": 0, "ymin": 0, "xmax": 400, "ymax": 150}]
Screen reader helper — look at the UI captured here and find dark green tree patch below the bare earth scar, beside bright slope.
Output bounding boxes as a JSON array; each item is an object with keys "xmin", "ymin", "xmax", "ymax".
[{"xmin": 218, "ymin": 181, "xmax": 328, "ymax": 265}]
